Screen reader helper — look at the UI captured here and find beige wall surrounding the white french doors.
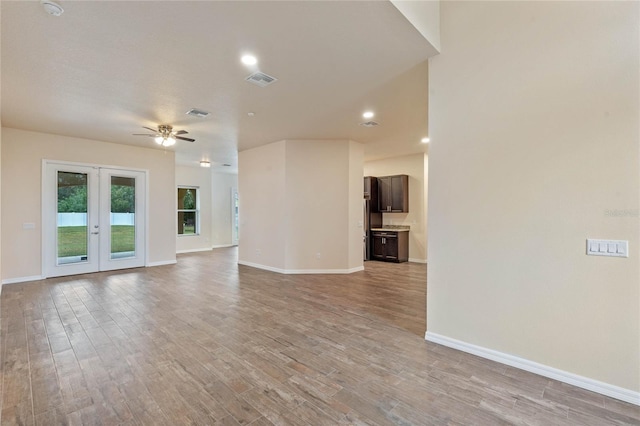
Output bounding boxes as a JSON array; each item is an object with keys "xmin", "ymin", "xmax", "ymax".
[{"xmin": 1, "ymin": 128, "xmax": 176, "ymax": 280}]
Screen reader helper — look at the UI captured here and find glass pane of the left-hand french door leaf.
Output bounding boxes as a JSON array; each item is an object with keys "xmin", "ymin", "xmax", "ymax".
[{"xmin": 56, "ymin": 171, "xmax": 88, "ymax": 265}]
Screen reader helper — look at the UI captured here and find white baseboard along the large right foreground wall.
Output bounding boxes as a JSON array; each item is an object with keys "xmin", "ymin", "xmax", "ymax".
[{"xmin": 424, "ymin": 331, "xmax": 640, "ymax": 405}]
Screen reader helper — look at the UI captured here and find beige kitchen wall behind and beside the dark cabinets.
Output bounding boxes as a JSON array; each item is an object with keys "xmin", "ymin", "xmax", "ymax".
[{"xmin": 364, "ymin": 153, "xmax": 427, "ymax": 263}]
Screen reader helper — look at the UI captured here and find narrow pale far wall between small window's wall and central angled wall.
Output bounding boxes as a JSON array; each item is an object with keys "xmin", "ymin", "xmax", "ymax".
[{"xmin": 211, "ymin": 172, "xmax": 238, "ymax": 247}]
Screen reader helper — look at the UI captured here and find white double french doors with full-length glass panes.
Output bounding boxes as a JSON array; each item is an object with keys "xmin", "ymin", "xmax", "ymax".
[{"xmin": 43, "ymin": 161, "xmax": 146, "ymax": 277}]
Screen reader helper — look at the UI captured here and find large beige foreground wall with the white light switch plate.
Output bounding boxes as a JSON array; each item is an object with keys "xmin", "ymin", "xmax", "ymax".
[{"xmin": 427, "ymin": 2, "xmax": 640, "ymax": 392}]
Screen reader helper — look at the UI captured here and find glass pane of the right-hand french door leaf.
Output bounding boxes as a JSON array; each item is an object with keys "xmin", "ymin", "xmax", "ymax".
[{"xmin": 110, "ymin": 176, "xmax": 136, "ymax": 259}]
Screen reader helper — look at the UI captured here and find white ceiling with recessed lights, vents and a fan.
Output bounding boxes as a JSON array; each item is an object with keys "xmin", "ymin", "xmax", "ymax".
[{"xmin": 1, "ymin": 0, "xmax": 432, "ymax": 169}]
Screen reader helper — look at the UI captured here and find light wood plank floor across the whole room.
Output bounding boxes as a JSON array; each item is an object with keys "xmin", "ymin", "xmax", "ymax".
[{"xmin": 0, "ymin": 249, "xmax": 640, "ymax": 426}]
